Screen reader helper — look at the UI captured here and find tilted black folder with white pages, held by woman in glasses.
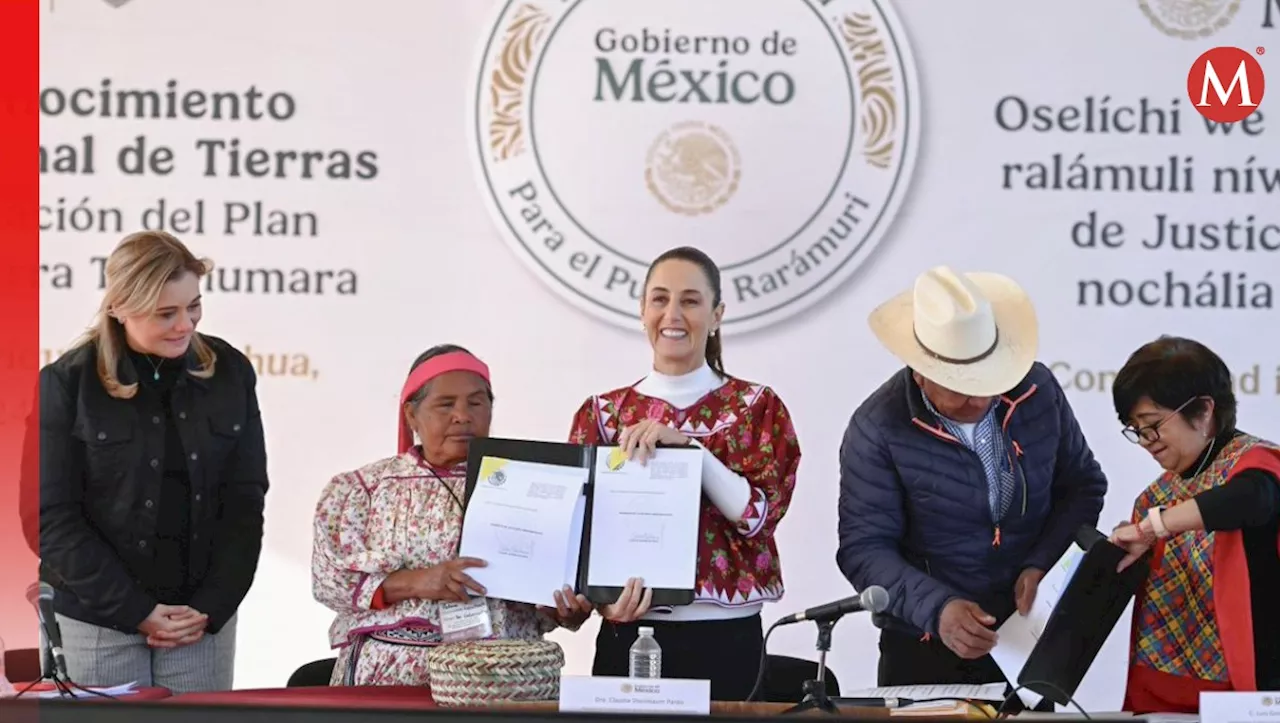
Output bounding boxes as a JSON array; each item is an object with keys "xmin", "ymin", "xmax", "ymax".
[{"xmin": 991, "ymin": 527, "xmax": 1151, "ymax": 706}]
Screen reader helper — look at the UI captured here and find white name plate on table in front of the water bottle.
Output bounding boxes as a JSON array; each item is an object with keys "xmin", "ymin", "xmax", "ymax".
[{"xmin": 559, "ymin": 676, "xmax": 712, "ymax": 715}]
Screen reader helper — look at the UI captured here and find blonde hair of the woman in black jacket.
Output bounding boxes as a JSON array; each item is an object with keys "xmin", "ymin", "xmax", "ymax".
[{"xmin": 76, "ymin": 230, "xmax": 218, "ymax": 399}]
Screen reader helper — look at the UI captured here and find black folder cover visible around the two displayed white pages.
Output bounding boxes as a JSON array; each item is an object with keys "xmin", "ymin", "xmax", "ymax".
[{"xmin": 463, "ymin": 436, "xmax": 694, "ymax": 608}]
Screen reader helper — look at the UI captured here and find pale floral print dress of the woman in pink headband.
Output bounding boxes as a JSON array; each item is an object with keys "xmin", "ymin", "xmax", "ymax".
[{"xmin": 311, "ymin": 448, "xmax": 557, "ymax": 686}]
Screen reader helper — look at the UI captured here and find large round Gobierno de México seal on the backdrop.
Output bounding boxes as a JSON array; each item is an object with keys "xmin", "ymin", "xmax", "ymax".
[{"xmin": 467, "ymin": 0, "xmax": 920, "ymax": 331}]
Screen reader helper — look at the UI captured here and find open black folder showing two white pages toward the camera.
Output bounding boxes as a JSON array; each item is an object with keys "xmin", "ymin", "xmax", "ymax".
[{"xmin": 458, "ymin": 438, "xmax": 703, "ymax": 607}]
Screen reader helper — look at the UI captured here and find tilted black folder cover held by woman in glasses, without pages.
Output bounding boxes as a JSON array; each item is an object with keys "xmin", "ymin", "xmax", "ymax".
[{"xmin": 1015, "ymin": 526, "xmax": 1151, "ymax": 705}]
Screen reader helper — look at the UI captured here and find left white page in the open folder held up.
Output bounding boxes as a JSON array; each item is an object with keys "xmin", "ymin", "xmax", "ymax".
[{"xmin": 458, "ymin": 457, "xmax": 588, "ymax": 607}]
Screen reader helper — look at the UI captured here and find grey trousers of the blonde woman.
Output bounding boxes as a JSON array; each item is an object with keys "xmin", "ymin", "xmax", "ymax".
[{"xmin": 58, "ymin": 616, "xmax": 236, "ymax": 695}]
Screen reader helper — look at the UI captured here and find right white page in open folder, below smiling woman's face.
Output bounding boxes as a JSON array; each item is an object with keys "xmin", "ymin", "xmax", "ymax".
[{"xmin": 586, "ymin": 447, "xmax": 703, "ymax": 590}]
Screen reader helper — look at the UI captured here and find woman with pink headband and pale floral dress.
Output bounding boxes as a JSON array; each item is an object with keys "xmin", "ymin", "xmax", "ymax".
[{"xmin": 311, "ymin": 344, "xmax": 593, "ymax": 686}]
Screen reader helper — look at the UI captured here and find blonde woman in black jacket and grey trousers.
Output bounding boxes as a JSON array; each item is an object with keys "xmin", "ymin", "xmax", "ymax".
[{"xmin": 40, "ymin": 232, "xmax": 268, "ymax": 694}]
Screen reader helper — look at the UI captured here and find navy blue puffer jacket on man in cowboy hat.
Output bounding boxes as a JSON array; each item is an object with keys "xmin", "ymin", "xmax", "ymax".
[{"xmin": 836, "ymin": 363, "xmax": 1107, "ymax": 635}]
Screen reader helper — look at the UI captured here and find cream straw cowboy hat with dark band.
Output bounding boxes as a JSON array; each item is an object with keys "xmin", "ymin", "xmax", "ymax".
[{"xmin": 869, "ymin": 266, "xmax": 1039, "ymax": 397}]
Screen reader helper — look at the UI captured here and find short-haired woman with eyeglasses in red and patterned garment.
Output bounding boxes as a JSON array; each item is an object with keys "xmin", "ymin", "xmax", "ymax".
[{"xmin": 1111, "ymin": 337, "xmax": 1280, "ymax": 714}]
